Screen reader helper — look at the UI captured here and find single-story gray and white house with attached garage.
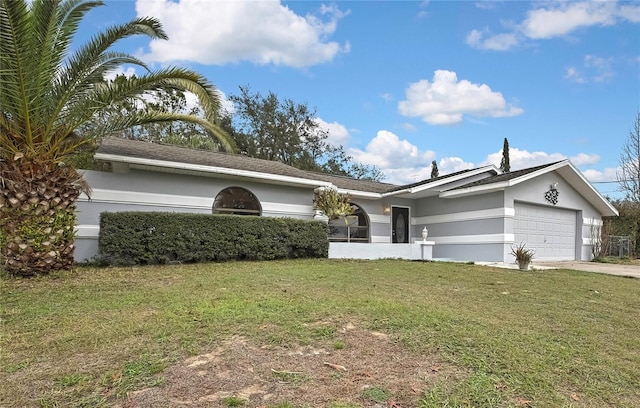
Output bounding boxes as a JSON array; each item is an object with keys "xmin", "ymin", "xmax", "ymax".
[{"xmin": 75, "ymin": 138, "xmax": 618, "ymax": 263}]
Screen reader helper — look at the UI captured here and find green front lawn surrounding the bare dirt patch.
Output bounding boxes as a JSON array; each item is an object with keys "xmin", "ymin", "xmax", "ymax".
[{"xmin": 0, "ymin": 260, "xmax": 640, "ymax": 408}]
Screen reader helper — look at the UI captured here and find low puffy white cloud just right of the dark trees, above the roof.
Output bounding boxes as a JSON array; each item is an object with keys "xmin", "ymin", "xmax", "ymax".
[{"xmin": 348, "ymin": 130, "xmax": 435, "ymax": 184}]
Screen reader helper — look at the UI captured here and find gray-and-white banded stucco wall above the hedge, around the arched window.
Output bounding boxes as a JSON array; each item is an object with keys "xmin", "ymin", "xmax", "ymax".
[{"xmin": 75, "ymin": 170, "xmax": 314, "ymax": 261}]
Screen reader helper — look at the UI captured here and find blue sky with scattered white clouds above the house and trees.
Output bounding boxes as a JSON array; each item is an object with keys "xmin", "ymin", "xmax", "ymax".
[{"xmin": 79, "ymin": 0, "xmax": 640, "ymax": 197}]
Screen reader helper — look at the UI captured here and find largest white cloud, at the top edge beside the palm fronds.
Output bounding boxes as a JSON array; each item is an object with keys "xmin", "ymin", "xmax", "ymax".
[{"xmin": 136, "ymin": 0, "xmax": 349, "ymax": 67}]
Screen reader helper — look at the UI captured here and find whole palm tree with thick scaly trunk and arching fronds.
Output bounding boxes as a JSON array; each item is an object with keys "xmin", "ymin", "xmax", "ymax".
[{"xmin": 0, "ymin": 0, "xmax": 234, "ymax": 275}]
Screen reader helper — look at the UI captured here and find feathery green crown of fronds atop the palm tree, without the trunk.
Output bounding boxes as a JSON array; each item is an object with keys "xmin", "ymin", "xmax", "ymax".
[{"xmin": 0, "ymin": 0, "xmax": 230, "ymax": 162}]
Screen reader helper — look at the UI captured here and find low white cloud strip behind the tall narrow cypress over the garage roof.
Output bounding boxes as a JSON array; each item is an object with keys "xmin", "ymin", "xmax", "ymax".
[{"xmin": 481, "ymin": 147, "xmax": 600, "ymax": 170}]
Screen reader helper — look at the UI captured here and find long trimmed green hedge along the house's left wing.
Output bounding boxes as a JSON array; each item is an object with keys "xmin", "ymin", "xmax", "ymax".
[{"xmin": 98, "ymin": 212, "xmax": 329, "ymax": 265}]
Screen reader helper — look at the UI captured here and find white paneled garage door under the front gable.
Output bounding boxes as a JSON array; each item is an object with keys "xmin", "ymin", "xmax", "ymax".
[{"xmin": 513, "ymin": 203, "xmax": 576, "ymax": 262}]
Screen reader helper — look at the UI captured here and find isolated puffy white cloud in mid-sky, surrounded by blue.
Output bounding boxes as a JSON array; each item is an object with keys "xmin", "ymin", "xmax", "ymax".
[{"xmin": 398, "ymin": 70, "xmax": 523, "ymax": 125}]
